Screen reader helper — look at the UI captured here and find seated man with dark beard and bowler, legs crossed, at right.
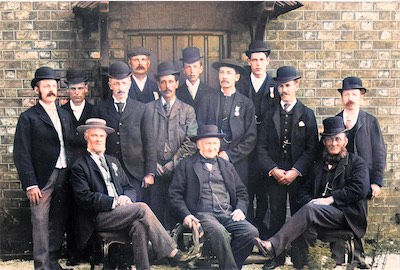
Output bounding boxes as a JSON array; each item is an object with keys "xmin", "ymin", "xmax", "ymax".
[{"xmin": 254, "ymin": 116, "xmax": 369, "ymax": 269}]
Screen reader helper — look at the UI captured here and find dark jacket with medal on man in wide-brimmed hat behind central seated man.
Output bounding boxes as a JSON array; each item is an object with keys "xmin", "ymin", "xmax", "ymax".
[{"xmin": 197, "ymin": 91, "xmax": 257, "ymax": 164}]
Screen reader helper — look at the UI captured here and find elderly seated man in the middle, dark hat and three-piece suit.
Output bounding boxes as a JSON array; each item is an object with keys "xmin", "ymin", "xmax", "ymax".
[{"xmin": 169, "ymin": 125, "xmax": 258, "ymax": 269}]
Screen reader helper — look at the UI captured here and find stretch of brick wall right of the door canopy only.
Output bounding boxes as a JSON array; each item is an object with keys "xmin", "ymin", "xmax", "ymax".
[{"xmin": 265, "ymin": 1, "xmax": 400, "ymax": 243}]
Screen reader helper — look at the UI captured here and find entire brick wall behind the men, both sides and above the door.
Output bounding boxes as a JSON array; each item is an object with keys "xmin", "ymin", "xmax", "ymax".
[{"xmin": 0, "ymin": 1, "xmax": 400, "ymax": 257}]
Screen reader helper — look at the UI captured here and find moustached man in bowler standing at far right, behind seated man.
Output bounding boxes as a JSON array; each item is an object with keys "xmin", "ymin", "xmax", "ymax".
[{"xmin": 332, "ymin": 77, "xmax": 386, "ymax": 269}]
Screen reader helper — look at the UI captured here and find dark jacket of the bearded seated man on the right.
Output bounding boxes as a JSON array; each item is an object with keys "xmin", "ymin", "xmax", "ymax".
[{"xmin": 298, "ymin": 153, "xmax": 369, "ymax": 239}]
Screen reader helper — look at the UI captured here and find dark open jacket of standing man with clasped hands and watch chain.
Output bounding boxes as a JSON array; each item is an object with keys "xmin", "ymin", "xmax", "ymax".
[{"xmin": 257, "ymin": 100, "xmax": 318, "ymax": 176}]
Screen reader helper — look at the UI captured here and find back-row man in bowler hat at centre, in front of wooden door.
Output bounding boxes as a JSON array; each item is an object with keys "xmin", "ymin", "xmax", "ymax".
[{"xmin": 176, "ymin": 47, "xmax": 213, "ymax": 112}]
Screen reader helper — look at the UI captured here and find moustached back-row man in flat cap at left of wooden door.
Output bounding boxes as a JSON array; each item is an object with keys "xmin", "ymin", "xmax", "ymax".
[{"xmin": 128, "ymin": 47, "xmax": 159, "ymax": 103}]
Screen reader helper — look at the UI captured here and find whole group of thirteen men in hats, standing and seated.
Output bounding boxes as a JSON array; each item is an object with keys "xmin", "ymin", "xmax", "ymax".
[{"xmin": 14, "ymin": 40, "xmax": 386, "ymax": 270}]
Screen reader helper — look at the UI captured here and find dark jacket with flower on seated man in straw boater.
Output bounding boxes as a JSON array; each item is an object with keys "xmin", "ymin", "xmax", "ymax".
[{"xmin": 71, "ymin": 152, "xmax": 136, "ymax": 249}]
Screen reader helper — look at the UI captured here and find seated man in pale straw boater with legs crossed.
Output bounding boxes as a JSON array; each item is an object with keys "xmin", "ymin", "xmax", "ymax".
[{"xmin": 71, "ymin": 118, "xmax": 198, "ymax": 269}]
